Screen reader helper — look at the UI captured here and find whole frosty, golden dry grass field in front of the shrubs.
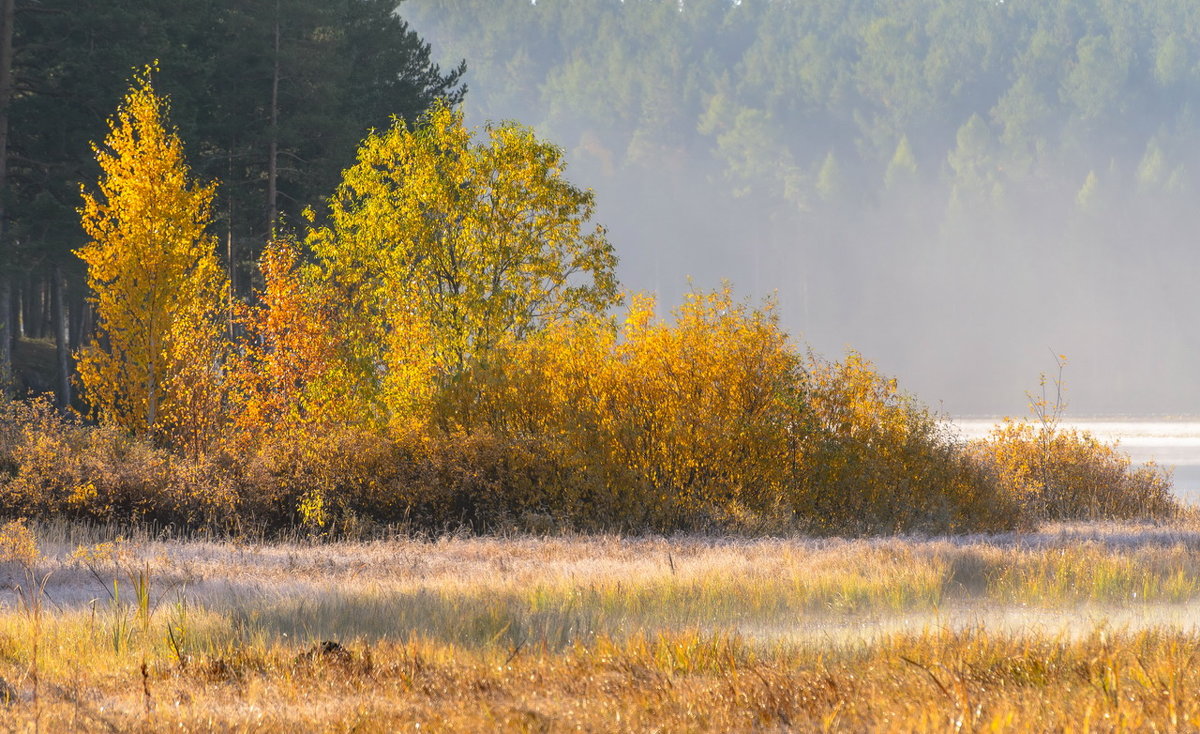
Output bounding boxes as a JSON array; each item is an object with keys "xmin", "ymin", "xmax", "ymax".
[{"xmin": 0, "ymin": 522, "xmax": 1200, "ymax": 733}]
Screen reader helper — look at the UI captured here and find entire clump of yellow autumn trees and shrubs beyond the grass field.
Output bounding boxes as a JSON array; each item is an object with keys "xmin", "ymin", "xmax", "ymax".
[{"xmin": 0, "ymin": 67, "xmax": 1176, "ymax": 533}]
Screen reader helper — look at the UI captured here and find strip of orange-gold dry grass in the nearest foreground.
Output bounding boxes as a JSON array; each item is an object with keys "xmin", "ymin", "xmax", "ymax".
[{"xmin": 0, "ymin": 626, "xmax": 1200, "ymax": 732}]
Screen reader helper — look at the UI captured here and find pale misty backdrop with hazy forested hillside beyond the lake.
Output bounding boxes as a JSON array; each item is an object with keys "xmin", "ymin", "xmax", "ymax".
[{"xmin": 401, "ymin": 0, "xmax": 1200, "ymax": 419}]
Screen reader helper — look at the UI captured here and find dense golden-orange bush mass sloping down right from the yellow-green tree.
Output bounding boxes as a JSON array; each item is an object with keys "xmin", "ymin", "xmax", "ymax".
[{"xmin": 438, "ymin": 289, "xmax": 1013, "ymax": 533}]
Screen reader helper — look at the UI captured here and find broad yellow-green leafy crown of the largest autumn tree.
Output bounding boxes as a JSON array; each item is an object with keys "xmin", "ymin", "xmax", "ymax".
[{"xmin": 308, "ymin": 103, "xmax": 617, "ymax": 426}]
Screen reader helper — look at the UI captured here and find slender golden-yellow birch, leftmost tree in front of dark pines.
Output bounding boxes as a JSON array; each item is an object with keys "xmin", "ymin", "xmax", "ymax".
[{"xmin": 77, "ymin": 68, "xmax": 226, "ymax": 445}]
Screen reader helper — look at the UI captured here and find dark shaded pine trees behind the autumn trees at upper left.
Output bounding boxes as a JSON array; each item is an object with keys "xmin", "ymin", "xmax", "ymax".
[{"xmin": 0, "ymin": 0, "xmax": 466, "ymax": 403}]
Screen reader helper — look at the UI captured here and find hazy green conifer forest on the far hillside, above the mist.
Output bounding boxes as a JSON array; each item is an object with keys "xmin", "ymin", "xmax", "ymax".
[{"xmin": 406, "ymin": 0, "xmax": 1200, "ymax": 220}]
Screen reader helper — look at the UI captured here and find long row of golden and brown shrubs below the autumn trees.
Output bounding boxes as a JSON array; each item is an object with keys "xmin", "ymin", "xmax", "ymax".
[{"xmin": 0, "ymin": 291, "xmax": 1174, "ymax": 534}]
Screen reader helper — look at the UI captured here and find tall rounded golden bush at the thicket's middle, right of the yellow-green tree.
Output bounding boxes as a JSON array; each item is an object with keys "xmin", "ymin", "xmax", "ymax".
[{"xmin": 608, "ymin": 288, "xmax": 808, "ymax": 519}]
